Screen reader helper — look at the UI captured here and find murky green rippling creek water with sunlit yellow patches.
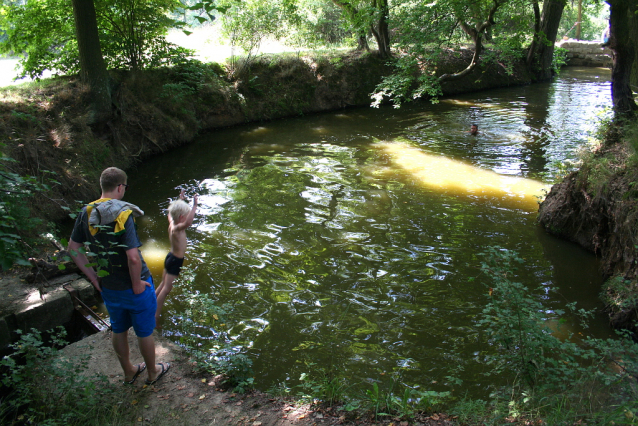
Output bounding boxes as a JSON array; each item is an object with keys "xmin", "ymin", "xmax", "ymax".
[{"xmin": 127, "ymin": 69, "xmax": 611, "ymax": 394}]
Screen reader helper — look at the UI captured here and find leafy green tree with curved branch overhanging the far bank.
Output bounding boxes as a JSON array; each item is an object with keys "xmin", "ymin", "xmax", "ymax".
[{"xmin": 372, "ymin": 0, "xmax": 526, "ymax": 106}]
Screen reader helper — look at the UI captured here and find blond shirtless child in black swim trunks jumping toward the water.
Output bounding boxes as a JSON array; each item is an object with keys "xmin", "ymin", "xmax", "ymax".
[{"xmin": 155, "ymin": 189, "xmax": 197, "ymax": 322}]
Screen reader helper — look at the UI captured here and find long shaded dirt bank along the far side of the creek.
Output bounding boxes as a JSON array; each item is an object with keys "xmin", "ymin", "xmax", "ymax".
[{"xmin": 0, "ymin": 50, "xmax": 530, "ymax": 226}]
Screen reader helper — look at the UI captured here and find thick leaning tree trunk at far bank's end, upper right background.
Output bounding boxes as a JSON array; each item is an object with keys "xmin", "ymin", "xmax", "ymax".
[{"xmin": 527, "ymin": 0, "xmax": 565, "ymax": 81}]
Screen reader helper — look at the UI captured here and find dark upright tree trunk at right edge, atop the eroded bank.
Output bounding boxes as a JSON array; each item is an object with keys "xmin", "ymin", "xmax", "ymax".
[{"xmin": 607, "ymin": 0, "xmax": 638, "ymax": 116}]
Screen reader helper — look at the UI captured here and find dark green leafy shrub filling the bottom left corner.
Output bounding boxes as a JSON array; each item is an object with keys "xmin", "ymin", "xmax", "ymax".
[{"xmin": 0, "ymin": 328, "xmax": 112, "ymax": 426}]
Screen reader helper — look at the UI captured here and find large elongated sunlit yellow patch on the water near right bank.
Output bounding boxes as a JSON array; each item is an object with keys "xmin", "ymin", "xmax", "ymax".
[{"xmin": 376, "ymin": 142, "xmax": 548, "ymax": 211}]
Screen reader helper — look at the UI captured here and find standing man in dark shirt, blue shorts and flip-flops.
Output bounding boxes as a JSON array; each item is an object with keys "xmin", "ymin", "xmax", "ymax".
[{"xmin": 69, "ymin": 167, "xmax": 170, "ymax": 385}]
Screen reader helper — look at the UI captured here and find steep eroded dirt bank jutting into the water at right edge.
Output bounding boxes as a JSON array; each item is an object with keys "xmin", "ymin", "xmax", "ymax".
[{"xmin": 538, "ymin": 126, "xmax": 638, "ymax": 333}]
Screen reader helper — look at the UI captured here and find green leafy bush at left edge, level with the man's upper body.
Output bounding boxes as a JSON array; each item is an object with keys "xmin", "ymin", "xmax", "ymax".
[{"xmin": 0, "ymin": 150, "xmax": 49, "ymax": 270}]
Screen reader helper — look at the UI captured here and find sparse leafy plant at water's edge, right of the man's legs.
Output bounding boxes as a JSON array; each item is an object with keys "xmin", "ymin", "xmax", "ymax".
[{"xmin": 180, "ymin": 293, "xmax": 254, "ymax": 392}]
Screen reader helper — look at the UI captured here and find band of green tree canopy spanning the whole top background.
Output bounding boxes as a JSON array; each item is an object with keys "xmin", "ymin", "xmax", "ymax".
[{"xmin": 0, "ymin": 0, "xmax": 635, "ymax": 115}]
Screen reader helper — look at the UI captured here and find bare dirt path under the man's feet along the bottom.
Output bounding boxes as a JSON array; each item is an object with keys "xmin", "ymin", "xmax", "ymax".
[{"xmin": 62, "ymin": 331, "xmax": 460, "ymax": 426}]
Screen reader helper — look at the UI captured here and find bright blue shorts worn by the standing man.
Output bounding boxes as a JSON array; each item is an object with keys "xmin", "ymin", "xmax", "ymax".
[{"xmin": 102, "ymin": 277, "xmax": 157, "ymax": 337}]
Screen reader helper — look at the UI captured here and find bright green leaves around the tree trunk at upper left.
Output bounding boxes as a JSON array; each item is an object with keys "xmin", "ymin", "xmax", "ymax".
[{"xmin": 0, "ymin": 0, "xmax": 190, "ymax": 78}]
